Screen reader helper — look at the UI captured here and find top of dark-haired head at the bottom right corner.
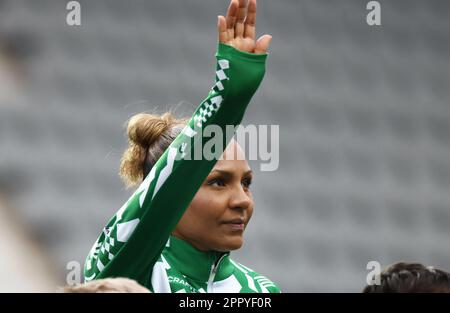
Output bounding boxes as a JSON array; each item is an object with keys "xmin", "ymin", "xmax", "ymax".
[{"xmin": 363, "ymin": 263, "xmax": 450, "ymax": 293}]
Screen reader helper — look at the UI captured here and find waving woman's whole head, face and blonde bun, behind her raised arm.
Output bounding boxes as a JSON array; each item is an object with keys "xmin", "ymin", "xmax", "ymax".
[{"xmin": 120, "ymin": 113, "xmax": 253, "ymax": 252}]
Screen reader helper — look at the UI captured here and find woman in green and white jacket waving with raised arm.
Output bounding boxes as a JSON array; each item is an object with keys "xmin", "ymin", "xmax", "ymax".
[{"xmin": 85, "ymin": 0, "xmax": 280, "ymax": 292}]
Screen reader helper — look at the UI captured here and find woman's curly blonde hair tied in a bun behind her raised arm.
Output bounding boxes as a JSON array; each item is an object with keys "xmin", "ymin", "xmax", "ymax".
[{"xmin": 119, "ymin": 112, "xmax": 188, "ymax": 188}]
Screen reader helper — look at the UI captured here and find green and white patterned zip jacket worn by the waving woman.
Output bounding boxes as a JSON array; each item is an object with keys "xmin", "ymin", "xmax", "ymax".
[{"xmin": 84, "ymin": 43, "xmax": 280, "ymax": 292}]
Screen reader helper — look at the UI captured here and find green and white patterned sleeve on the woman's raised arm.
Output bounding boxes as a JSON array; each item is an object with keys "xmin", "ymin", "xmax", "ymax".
[{"xmin": 84, "ymin": 44, "xmax": 267, "ymax": 285}]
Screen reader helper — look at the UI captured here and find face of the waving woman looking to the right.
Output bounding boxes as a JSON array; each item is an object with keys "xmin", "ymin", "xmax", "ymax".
[{"xmin": 173, "ymin": 139, "xmax": 253, "ymax": 252}]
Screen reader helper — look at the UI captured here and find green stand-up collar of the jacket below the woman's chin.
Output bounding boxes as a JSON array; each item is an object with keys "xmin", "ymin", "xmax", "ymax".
[{"xmin": 164, "ymin": 236, "xmax": 234, "ymax": 282}]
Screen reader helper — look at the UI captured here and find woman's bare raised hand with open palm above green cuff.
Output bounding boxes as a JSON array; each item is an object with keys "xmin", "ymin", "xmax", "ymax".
[{"xmin": 217, "ymin": 0, "xmax": 272, "ymax": 54}]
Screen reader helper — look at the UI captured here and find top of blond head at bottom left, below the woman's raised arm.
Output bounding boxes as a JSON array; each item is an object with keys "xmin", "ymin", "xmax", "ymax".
[{"xmin": 62, "ymin": 278, "xmax": 150, "ymax": 293}]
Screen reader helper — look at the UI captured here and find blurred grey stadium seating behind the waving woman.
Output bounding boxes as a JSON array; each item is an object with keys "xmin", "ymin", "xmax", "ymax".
[{"xmin": 0, "ymin": 0, "xmax": 450, "ymax": 292}]
